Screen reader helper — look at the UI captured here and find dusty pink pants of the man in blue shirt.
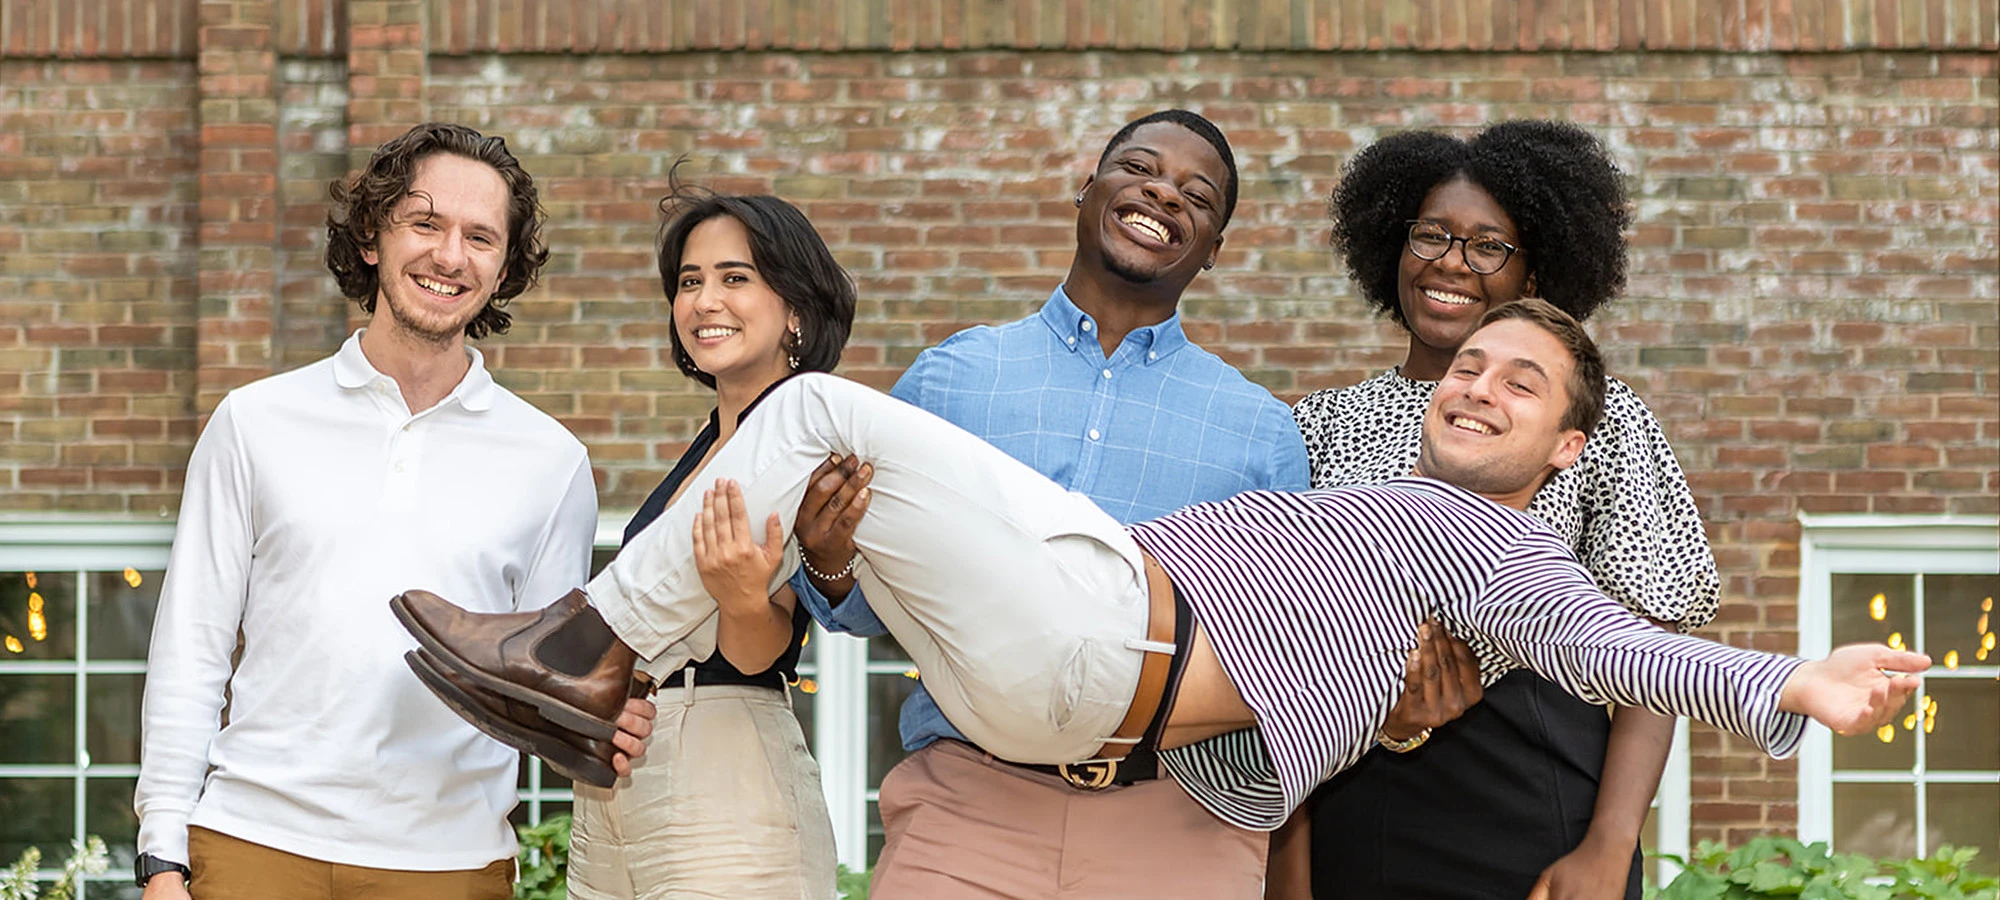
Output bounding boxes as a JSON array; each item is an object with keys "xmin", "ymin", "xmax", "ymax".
[{"xmin": 868, "ymin": 740, "xmax": 1270, "ymax": 900}]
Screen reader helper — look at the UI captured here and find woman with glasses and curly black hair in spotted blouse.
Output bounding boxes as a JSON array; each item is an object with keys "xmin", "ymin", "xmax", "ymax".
[{"xmin": 1272, "ymin": 120, "xmax": 1720, "ymax": 900}]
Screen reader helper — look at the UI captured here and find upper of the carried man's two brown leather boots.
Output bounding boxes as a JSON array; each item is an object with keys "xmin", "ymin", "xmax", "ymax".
[{"xmin": 388, "ymin": 590, "xmax": 638, "ymax": 740}]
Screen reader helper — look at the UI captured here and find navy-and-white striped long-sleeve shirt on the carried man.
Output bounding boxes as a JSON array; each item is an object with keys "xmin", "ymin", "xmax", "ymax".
[{"xmin": 1132, "ymin": 478, "xmax": 1804, "ymax": 830}]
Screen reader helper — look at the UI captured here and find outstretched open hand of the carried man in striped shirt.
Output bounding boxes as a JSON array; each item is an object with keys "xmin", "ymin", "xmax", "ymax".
[{"xmin": 1778, "ymin": 644, "xmax": 1930, "ymax": 734}]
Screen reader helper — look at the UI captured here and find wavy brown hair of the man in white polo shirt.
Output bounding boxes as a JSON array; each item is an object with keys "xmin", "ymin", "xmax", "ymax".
[{"xmin": 326, "ymin": 122, "xmax": 548, "ymax": 338}]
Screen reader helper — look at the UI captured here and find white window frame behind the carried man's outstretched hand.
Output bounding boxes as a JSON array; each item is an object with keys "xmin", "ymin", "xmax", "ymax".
[{"xmin": 1798, "ymin": 512, "xmax": 2000, "ymax": 854}]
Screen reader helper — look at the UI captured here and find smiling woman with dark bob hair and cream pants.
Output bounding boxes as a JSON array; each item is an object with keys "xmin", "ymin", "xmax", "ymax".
[{"xmin": 570, "ymin": 186, "xmax": 866, "ymax": 900}]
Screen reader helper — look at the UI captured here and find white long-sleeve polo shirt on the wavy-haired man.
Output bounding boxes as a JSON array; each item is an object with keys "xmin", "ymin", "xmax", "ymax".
[{"xmin": 134, "ymin": 332, "xmax": 596, "ymax": 870}]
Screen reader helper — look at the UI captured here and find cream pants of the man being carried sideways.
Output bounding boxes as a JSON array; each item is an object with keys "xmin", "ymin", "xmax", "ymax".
[{"xmin": 586, "ymin": 374, "xmax": 1172, "ymax": 762}]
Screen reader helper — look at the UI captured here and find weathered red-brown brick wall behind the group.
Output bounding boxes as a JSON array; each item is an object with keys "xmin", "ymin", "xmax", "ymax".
[{"xmin": 0, "ymin": 0, "xmax": 2000, "ymax": 848}]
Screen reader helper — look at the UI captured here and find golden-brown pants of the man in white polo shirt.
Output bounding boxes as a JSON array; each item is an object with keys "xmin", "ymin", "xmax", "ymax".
[{"xmin": 188, "ymin": 826, "xmax": 514, "ymax": 900}]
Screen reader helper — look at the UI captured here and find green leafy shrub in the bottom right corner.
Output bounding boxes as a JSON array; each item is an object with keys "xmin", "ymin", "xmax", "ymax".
[{"xmin": 1646, "ymin": 838, "xmax": 2000, "ymax": 900}]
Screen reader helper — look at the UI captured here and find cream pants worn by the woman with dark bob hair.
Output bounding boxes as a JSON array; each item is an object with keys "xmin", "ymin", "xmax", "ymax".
[{"xmin": 570, "ymin": 684, "xmax": 834, "ymax": 900}]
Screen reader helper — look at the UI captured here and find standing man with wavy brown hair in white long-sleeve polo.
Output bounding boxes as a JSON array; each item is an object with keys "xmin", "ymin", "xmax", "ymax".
[{"xmin": 134, "ymin": 124, "xmax": 650, "ymax": 900}]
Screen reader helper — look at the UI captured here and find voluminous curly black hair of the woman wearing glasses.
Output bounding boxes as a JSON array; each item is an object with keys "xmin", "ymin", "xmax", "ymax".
[{"xmin": 1330, "ymin": 120, "xmax": 1632, "ymax": 328}]
